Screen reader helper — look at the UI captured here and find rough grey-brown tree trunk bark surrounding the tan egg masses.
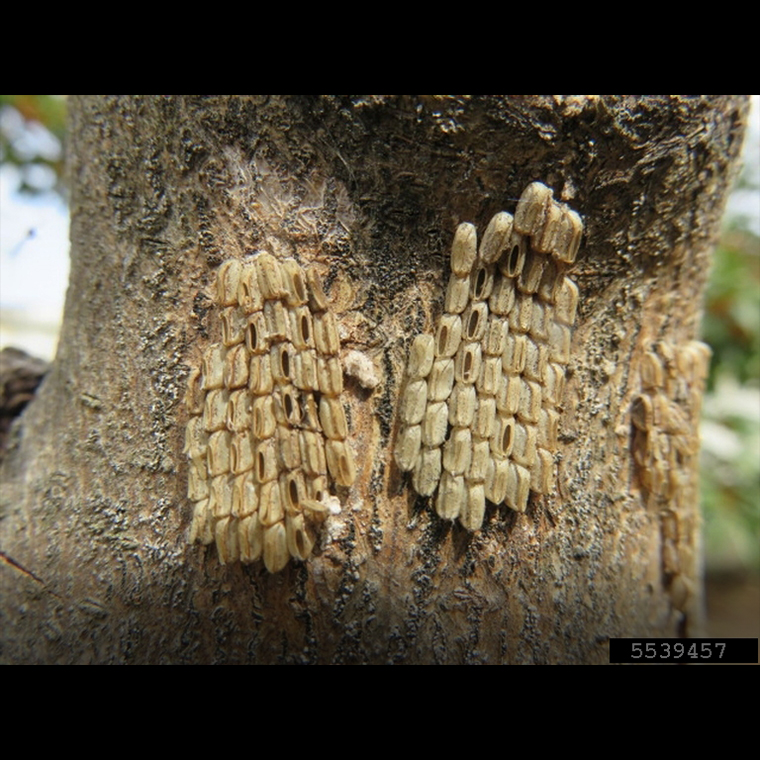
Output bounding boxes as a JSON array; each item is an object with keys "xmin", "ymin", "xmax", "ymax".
[{"xmin": 0, "ymin": 96, "xmax": 747, "ymax": 663}]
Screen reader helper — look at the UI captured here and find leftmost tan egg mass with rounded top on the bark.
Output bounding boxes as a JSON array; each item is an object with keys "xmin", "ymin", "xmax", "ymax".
[{"xmin": 185, "ymin": 252, "xmax": 354, "ymax": 573}]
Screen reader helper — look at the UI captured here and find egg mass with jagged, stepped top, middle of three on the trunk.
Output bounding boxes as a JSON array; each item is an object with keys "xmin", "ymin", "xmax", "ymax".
[{"xmin": 395, "ymin": 182, "xmax": 584, "ymax": 531}]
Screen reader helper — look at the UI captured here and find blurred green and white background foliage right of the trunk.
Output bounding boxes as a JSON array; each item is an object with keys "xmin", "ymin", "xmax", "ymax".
[{"xmin": 701, "ymin": 159, "xmax": 760, "ymax": 572}]
